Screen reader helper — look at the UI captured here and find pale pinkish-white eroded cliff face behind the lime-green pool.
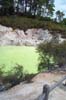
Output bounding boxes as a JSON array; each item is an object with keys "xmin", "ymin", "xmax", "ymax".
[{"xmin": 0, "ymin": 25, "xmax": 65, "ymax": 46}]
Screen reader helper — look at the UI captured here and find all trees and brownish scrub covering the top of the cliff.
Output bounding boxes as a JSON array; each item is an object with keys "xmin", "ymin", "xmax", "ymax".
[{"xmin": 0, "ymin": 0, "xmax": 66, "ymax": 31}]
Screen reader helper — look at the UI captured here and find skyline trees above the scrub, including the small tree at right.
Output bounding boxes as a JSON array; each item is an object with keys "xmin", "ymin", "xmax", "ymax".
[{"xmin": 0, "ymin": 0, "xmax": 64, "ymax": 23}]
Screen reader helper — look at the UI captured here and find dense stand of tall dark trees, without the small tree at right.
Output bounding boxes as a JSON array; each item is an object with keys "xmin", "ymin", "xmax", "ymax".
[{"xmin": 0, "ymin": 0, "xmax": 54, "ymax": 16}]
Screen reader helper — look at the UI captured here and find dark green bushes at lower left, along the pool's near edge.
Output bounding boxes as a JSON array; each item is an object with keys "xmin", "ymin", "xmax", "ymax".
[{"xmin": 0, "ymin": 64, "xmax": 35, "ymax": 89}]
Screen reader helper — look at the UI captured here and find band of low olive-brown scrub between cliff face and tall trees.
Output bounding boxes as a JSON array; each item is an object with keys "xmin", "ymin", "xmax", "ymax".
[{"xmin": 0, "ymin": 16, "xmax": 66, "ymax": 33}]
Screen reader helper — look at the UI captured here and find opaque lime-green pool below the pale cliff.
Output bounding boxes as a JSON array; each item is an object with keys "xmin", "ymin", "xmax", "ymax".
[{"xmin": 0, "ymin": 46, "xmax": 38, "ymax": 73}]
